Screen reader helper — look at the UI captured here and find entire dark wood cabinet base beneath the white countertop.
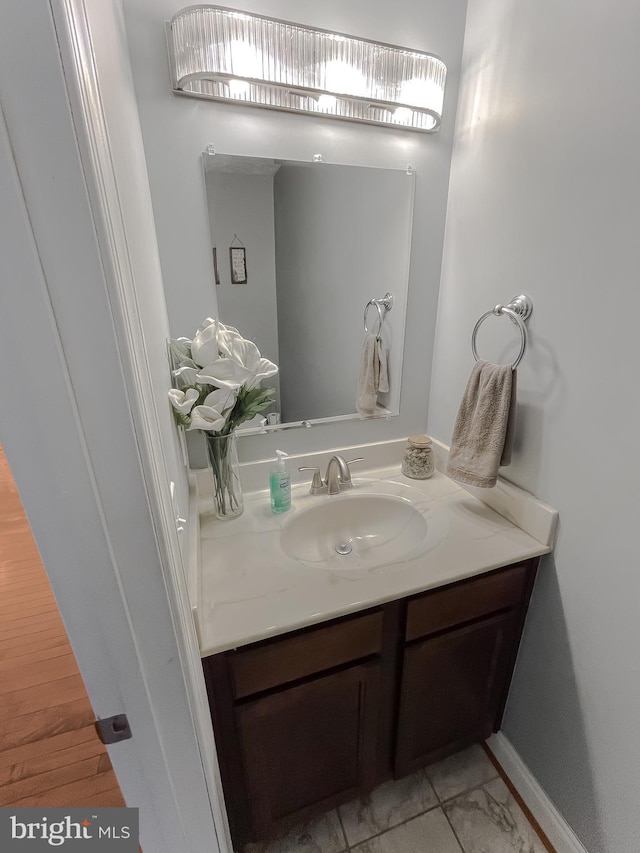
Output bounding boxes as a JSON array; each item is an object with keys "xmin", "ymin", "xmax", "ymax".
[{"xmin": 203, "ymin": 559, "xmax": 538, "ymax": 850}]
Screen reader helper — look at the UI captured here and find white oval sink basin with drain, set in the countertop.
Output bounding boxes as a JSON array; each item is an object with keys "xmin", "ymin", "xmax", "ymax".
[{"xmin": 280, "ymin": 494, "xmax": 427, "ymax": 571}]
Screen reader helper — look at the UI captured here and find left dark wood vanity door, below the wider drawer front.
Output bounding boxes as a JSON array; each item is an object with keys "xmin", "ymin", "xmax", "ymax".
[{"xmin": 236, "ymin": 662, "xmax": 380, "ymax": 839}]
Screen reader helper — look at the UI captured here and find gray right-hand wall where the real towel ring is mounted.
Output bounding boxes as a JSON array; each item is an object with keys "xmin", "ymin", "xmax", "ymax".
[{"xmin": 429, "ymin": 0, "xmax": 640, "ymax": 853}]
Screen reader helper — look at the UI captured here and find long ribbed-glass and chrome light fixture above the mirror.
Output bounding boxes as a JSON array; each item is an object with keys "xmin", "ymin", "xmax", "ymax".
[{"xmin": 167, "ymin": 6, "xmax": 447, "ymax": 132}]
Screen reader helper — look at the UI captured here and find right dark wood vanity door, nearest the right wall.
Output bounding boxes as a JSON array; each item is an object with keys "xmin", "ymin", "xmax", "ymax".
[{"xmin": 394, "ymin": 611, "xmax": 518, "ymax": 777}]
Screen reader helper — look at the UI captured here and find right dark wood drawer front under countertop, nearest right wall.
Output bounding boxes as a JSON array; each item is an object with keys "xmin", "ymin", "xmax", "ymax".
[{"xmin": 405, "ymin": 563, "xmax": 530, "ymax": 640}]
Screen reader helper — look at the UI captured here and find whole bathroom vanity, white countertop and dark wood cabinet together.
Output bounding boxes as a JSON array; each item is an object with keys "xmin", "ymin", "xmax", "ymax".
[{"xmin": 192, "ymin": 442, "xmax": 555, "ymax": 850}]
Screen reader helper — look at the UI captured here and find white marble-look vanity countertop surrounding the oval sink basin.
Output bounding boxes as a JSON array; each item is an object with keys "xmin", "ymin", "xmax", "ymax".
[{"xmin": 195, "ymin": 452, "xmax": 557, "ymax": 657}]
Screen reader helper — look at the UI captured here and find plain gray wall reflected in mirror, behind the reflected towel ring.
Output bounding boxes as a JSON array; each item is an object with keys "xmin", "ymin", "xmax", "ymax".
[{"xmin": 274, "ymin": 164, "xmax": 415, "ymax": 421}]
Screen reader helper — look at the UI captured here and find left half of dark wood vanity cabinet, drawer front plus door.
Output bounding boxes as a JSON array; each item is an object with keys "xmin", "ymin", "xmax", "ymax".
[{"xmin": 203, "ymin": 608, "xmax": 384, "ymax": 850}]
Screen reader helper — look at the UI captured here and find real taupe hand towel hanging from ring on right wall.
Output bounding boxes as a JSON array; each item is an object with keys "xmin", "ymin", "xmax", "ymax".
[{"xmin": 447, "ymin": 361, "xmax": 516, "ymax": 488}]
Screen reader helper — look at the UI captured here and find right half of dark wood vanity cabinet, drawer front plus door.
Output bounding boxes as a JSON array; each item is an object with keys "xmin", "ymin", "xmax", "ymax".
[{"xmin": 394, "ymin": 560, "xmax": 537, "ymax": 777}]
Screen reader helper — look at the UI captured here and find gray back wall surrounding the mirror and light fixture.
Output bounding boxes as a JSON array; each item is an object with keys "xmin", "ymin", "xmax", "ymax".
[{"xmin": 124, "ymin": 0, "xmax": 466, "ymax": 458}]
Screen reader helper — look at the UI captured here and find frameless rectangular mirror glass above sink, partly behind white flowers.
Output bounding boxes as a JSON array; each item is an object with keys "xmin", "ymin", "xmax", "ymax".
[{"xmin": 203, "ymin": 153, "xmax": 415, "ymax": 427}]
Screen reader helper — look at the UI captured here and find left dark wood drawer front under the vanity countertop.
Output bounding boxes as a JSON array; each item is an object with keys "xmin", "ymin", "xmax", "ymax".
[{"xmin": 227, "ymin": 611, "xmax": 383, "ymax": 699}]
